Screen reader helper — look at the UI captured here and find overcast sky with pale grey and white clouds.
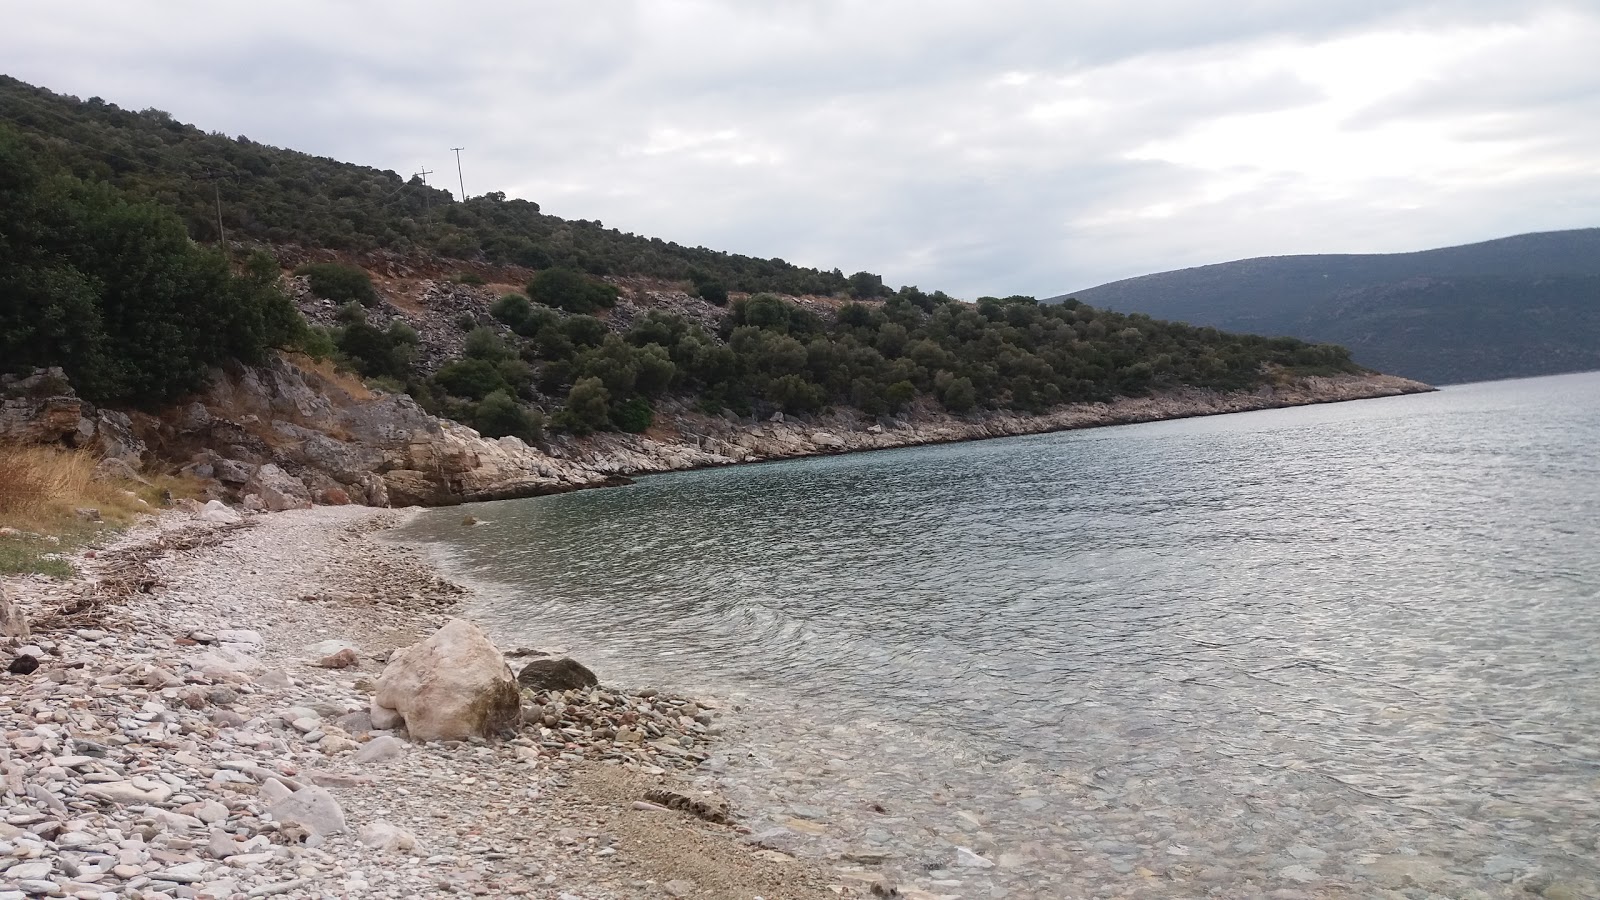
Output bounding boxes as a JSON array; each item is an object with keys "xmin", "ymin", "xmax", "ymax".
[{"xmin": 0, "ymin": 0, "xmax": 1600, "ymax": 298}]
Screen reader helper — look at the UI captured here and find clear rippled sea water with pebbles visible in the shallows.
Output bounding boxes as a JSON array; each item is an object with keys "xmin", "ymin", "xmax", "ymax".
[{"xmin": 406, "ymin": 373, "xmax": 1600, "ymax": 897}]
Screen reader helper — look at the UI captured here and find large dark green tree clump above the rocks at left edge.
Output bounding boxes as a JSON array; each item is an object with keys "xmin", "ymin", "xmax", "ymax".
[{"xmin": 0, "ymin": 130, "xmax": 306, "ymax": 405}]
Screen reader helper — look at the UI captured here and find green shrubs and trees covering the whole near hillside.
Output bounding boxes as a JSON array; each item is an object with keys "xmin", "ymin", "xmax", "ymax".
[{"xmin": 0, "ymin": 80, "xmax": 1360, "ymax": 440}]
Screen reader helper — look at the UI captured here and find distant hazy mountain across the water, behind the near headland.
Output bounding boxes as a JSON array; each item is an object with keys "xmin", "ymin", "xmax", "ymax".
[{"xmin": 1053, "ymin": 227, "xmax": 1600, "ymax": 384}]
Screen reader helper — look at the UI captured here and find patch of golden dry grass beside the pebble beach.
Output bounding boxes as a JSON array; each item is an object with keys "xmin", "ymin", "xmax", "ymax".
[{"xmin": 0, "ymin": 447, "xmax": 200, "ymax": 578}]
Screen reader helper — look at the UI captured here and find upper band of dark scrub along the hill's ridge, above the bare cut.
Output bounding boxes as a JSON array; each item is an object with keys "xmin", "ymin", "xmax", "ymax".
[{"xmin": 0, "ymin": 75, "xmax": 857, "ymax": 296}]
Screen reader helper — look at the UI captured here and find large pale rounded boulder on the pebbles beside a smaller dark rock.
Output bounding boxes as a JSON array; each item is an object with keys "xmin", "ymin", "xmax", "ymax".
[{"xmin": 373, "ymin": 618, "xmax": 522, "ymax": 740}]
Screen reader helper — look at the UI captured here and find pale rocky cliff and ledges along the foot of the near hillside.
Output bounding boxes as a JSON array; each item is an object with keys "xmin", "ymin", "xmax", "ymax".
[{"xmin": 0, "ymin": 357, "xmax": 1430, "ymax": 509}]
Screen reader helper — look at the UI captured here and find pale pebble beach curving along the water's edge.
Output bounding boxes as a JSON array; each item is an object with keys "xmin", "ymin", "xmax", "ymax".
[{"xmin": 0, "ymin": 506, "xmax": 886, "ymax": 900}]
